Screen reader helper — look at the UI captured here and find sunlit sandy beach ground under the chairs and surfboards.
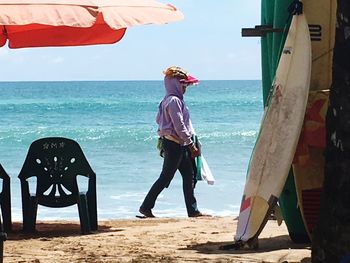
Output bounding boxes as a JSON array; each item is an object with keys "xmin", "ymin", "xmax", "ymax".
[{"xmin": 4, "ymin": 217, "xmax": 311, "ymax": 263}]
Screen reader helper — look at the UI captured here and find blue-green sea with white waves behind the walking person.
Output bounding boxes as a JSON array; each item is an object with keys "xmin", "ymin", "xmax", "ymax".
[{"xmin": 0, "ymin": 80, "xmax": 262, "ymax": 220}]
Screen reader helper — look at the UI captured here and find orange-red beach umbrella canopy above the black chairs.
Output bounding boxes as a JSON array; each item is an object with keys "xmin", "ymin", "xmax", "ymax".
[{"xmin": 0, "ymin": 0, "xmax": 183, "ymax": 48}]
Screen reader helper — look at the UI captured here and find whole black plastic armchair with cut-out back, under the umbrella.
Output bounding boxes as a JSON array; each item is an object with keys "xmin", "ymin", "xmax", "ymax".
[{"xmin": 18, "ymin": 137, "xmax": 97, "ymax": 234}]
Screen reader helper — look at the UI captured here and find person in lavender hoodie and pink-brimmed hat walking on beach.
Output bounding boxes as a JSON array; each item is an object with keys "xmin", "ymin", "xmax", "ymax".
[{"xmin": 139, "ymin": 67, "xmax": 203, "ymax": 217}]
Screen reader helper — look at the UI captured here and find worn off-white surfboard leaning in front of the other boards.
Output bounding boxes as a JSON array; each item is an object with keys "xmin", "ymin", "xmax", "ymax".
[{"xmin": 235, "ymin": 11, "xmax": 311, "ymax": 246}]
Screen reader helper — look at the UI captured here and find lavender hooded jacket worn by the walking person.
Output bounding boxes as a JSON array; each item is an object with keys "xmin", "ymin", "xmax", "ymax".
[{"xmin": 156, "ymin": 77, "xmax": 194, "ymax": 145}]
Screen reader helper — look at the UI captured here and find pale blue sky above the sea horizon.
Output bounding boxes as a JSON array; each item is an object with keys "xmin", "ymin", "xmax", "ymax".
[{"xmin": 0, "ymin": 0, "xmax": 261, "ymax": 81}]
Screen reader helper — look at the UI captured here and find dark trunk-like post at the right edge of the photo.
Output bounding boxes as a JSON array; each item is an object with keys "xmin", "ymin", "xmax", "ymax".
[{"xmin": 312, "ymin": 0, "xmax": 350, "ymax": 263}]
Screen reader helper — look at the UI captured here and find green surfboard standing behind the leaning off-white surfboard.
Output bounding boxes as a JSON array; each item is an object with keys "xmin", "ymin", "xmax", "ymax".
[{"xmin": 261, "ymin": 0, "xmax": 310, "ymax": 243}]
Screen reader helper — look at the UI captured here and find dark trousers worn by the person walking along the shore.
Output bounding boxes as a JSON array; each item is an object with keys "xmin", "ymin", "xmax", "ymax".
[{"xmin": 141, "ymin": 139, "xmax": 198, "ymax": 216}]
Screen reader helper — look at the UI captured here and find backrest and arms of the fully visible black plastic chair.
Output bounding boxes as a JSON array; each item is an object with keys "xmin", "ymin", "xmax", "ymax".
[{"xmin": 18, "ymin": 137, "xmax": 96, "ymax": 207}]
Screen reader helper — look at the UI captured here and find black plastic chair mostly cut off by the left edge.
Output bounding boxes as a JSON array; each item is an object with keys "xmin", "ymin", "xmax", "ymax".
[{"xmin": 0, "ymin": 164, "xmax": 12, "ymax": 232}]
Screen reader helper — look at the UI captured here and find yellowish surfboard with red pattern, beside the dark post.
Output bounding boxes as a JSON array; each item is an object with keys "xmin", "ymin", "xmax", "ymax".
[{"xmin": 293, "ymin": 0, "xmax": 337, "ymax": 239}]
